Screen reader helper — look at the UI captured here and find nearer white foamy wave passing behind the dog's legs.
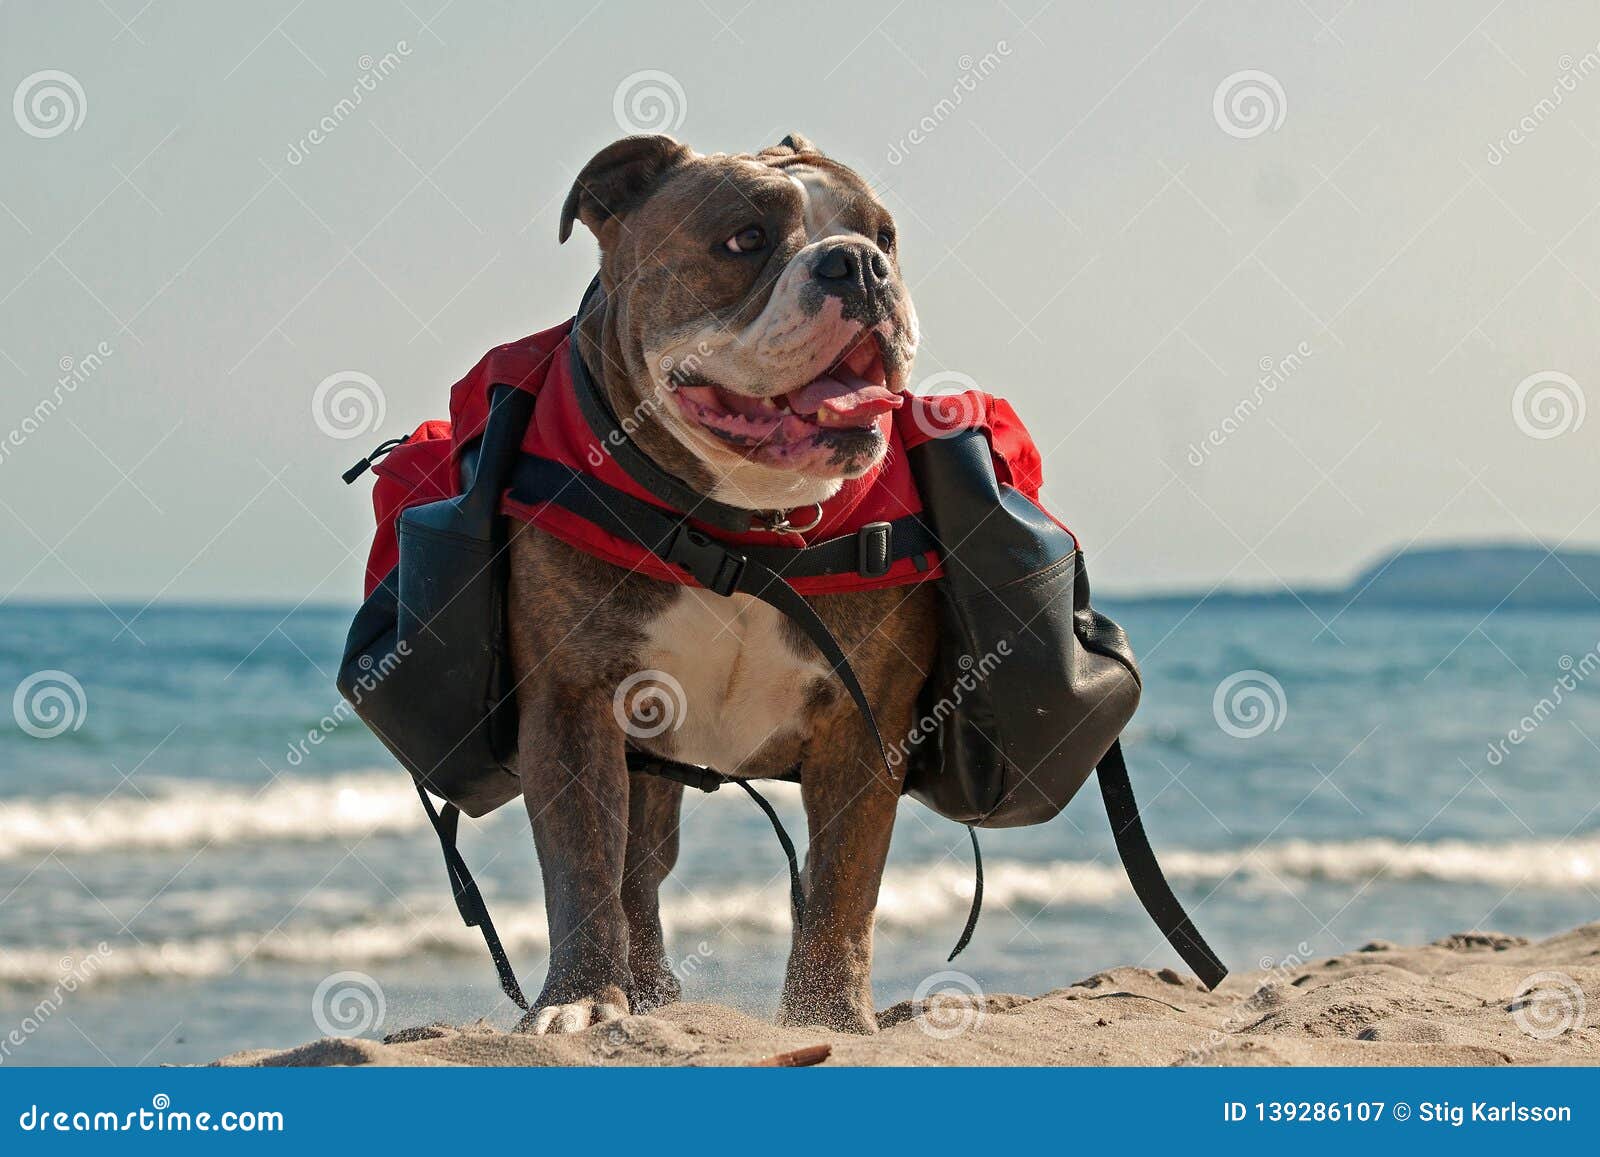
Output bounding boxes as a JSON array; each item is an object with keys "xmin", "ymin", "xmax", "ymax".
[{"xmin": 0, "ymin": 838, "xmax": 1600, "ymax": 987}]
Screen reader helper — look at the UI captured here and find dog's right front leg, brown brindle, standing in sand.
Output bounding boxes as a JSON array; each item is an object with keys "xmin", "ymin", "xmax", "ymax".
[{"xmin": 779, "ymin": 755, "xmax": 899, "ymax": 1032}]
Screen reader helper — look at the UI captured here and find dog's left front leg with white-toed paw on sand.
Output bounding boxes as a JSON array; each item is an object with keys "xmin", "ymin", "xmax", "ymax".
[{"xmin": 518, "ymin": 690, "xmax": 632, "ymax": 1034}]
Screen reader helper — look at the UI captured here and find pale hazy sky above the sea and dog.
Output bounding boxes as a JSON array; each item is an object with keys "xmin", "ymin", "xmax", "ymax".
[{"xmin": 0, "ymin": 0, "xmax": 1600, "ymax": 603}]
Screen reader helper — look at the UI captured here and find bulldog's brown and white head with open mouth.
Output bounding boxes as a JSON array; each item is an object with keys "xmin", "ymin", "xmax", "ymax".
[{"xmin": 562, "ymin": 136, "xmax": 917, "ymax": 509}]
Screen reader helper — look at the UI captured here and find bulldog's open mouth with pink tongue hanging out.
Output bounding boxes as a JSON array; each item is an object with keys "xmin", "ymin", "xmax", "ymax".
[{"xmin": 675, "ymin": 331, "xmax": 904, "ymax": 451}]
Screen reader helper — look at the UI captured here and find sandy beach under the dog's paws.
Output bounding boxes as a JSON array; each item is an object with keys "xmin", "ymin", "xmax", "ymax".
[{"xmin": 218, "ymin": 923, "xmax": 1600, "ymax": 1066}]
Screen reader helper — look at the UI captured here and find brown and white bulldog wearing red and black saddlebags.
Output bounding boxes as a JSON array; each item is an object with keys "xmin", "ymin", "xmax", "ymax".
[{"xmin": 507, "ymin": 136, "xmax": 936, "ymax": 1034}]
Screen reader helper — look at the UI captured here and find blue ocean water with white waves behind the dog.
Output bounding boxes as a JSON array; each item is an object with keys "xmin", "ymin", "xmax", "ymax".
[{"xmin": 0, "ymin": 600, "xmax": 1600, "ymax": 1064}]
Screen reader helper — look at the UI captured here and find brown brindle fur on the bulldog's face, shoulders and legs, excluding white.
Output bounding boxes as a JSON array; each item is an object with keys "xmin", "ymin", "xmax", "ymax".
[{"xmin": 509, "ymin": 138, "xmax": 934, "ymax": 1032}]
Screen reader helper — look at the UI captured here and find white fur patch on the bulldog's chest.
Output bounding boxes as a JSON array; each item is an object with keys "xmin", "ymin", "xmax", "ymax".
[{"xmin": 630, "ymin": 587, "xmax": 829, "ymax": 775}]
